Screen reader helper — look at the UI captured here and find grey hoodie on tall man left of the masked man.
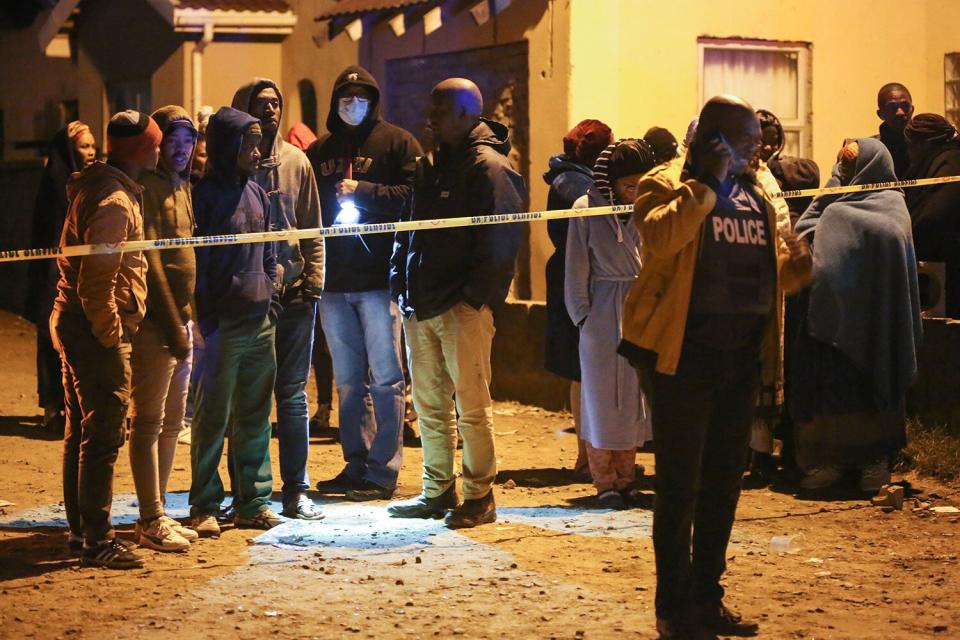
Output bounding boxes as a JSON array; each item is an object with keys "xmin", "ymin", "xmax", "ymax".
[{"xmin": 232, "ymin": 78, "xmax": 324, "ymax": 298}]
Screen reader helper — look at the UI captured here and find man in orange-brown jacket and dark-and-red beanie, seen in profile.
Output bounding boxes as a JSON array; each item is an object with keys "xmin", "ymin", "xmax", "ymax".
[{"xmin": 50, "ymin": 111, "xmax": 162, "ymax": 569}]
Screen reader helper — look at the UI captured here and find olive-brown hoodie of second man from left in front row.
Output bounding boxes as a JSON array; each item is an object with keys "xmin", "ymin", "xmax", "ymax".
[{"xmin": 140, "ymin": 105, "xmax": 197, "ymax": 359}]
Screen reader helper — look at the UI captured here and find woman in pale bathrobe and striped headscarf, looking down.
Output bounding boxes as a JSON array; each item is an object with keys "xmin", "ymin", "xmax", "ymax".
[{"xmin": 564, "ymin": 139, "xmax": 657, "ymax": 509}]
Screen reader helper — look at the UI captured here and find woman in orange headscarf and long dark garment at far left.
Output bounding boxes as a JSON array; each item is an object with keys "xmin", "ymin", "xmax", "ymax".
[{"xmin": 26, "ymin": 120, "xmax": 97, "ymax": 433}]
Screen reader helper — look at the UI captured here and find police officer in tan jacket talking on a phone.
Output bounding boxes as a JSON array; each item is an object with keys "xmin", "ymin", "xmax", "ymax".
[{"xmin": 620, "ymin": 96, "xmax": 813, "ymax": 638}]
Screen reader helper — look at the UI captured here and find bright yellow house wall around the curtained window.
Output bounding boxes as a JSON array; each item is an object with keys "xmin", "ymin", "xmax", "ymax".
[{"xmin": 570, "ymin": 0, "xmax": 960, "ymax": 182}]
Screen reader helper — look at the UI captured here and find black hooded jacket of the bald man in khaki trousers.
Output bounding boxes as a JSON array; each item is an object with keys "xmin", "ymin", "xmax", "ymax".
[{"xmin": 390, "ymin": 118, "xmax": 526, "ymax": 320}]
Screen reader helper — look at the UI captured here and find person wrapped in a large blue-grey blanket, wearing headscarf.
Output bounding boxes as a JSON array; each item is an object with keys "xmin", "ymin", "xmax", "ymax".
[{"xmin": 790, "ymin": 138, "xmax": 922, "ymax": 492}]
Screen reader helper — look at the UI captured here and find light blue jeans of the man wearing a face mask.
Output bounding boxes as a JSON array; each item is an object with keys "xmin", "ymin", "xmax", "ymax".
[{"xmin": 320, "ymin": 289, "xmax": 404, "ymax": 489}]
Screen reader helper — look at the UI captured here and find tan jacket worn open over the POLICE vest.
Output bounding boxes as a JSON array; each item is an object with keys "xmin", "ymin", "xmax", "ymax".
[{"xmin": 623, "ymin": 158, "xmax": 811, "ymax": 384}]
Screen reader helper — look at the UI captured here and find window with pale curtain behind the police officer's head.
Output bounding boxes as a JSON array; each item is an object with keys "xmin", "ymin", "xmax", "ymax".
[{"xmin": 697, "ymin": 38, "xmax": 813, "ymax": 158}]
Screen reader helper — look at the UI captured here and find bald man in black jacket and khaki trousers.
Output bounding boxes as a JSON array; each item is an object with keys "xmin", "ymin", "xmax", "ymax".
[{"xmin": 388, "ymin": 78, "xmax": 525, "ymax": 528}]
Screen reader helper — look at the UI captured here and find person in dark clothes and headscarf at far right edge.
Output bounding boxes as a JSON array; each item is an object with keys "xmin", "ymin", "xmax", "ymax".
[{"xmin": 904, "ymin": 113, "xmax": 960, "ymax": 318}]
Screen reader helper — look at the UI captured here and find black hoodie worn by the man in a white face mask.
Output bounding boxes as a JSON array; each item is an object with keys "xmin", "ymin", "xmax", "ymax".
[{"xmin": 307, "ymin": 66, "xmax": 423, "ymax": 292}]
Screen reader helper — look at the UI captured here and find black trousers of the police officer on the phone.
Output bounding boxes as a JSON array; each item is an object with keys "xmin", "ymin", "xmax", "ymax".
[{"xmin": 641, "ymin": 345, "xmax": 760, "ymax": 618}]
